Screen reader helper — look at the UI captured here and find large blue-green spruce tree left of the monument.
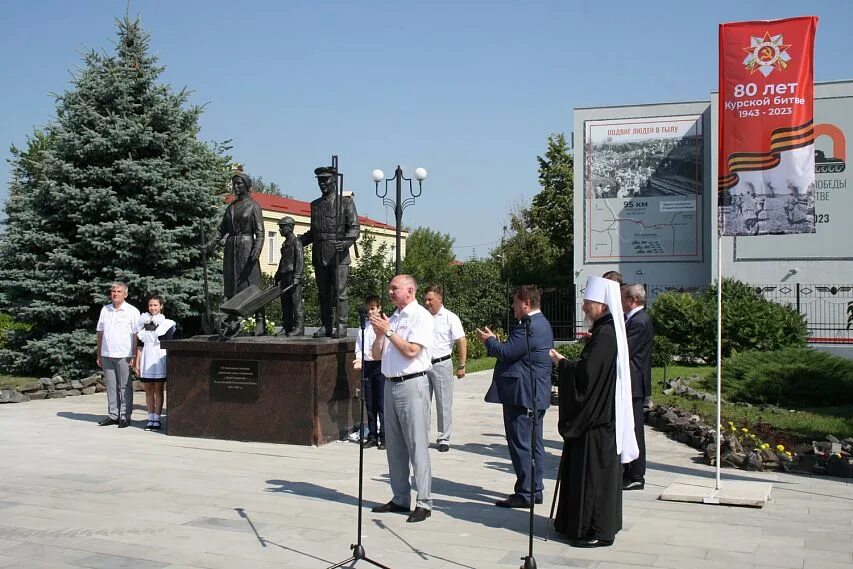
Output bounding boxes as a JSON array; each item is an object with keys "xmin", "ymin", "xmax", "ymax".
[{"xmin": 0, "ymin": 18, "xmax": 229, "ymax": 374}]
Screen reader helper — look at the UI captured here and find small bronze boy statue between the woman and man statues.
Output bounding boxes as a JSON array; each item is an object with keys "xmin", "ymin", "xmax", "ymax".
[{"xmin": 275, "ymin": 216, "xmax": 305, "ymax": 336}]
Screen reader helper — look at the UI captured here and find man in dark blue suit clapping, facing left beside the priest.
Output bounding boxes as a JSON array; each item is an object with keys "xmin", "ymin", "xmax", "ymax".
[{"xmin": 477, "ymin": 285, "xmax": 554, "ymax": 508}]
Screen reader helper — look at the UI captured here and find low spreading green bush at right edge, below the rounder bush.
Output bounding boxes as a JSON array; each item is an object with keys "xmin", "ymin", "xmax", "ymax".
[{"xmin": 704, "ymin": 348, "xmax": 853, "ymax": 409}]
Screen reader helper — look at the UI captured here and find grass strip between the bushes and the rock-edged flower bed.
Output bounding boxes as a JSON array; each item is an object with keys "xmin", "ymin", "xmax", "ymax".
[{"xmin": 652, "ymin": 366, "xmax": 853, "ymax": 442}]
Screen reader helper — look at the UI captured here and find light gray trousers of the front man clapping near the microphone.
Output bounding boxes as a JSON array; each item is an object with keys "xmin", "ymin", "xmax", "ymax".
[{"xmin": 385, "ymin": 375, "xmax": 432, "ymax": 510}]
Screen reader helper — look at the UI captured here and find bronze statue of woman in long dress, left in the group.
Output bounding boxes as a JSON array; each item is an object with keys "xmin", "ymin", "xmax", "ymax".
[{"xmin": 210, "ymin": 172, "xmax": 265, "ymax": 336}]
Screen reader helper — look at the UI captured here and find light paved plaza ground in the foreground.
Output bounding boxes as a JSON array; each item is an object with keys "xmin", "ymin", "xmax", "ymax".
[{"xmin": 0, "ymin": 371, "xmax": 853, "ymax": 569}]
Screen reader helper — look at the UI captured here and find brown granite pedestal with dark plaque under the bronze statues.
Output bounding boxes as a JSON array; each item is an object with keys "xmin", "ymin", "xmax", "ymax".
[{"xmin": 163, "ymin": 336, "xmax": 359, "ymax": 445}]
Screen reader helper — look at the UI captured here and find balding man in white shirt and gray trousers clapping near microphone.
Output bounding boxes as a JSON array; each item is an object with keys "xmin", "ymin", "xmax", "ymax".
[{"xmin": 370, "ymin": 275, "xmax": 434, "ymax": 522}]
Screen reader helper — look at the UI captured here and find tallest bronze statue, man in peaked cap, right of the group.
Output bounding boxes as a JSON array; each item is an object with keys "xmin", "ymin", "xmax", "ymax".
[{"xmin": 301, "ymin": 166, "xmax": 359, "ymax": 338}]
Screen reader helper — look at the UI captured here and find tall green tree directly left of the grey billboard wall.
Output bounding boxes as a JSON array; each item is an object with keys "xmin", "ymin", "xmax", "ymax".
[{"xmin": 493, "ymin": 134, "xmax": 574, "ymax": 287}]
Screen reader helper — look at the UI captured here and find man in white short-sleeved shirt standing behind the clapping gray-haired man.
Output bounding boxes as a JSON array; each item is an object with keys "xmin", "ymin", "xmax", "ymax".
[{"xmin": 424, "ymin": 285, "xmax": 468, "ymax": 452}]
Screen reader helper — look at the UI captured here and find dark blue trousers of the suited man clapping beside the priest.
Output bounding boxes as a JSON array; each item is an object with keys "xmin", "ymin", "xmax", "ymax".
[{"xmin": 503, "ymin": 405, "xmax": 545, "ymax": 502}]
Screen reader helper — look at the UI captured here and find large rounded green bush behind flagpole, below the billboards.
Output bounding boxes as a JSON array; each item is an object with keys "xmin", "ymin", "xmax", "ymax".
[{"xmin": 649, "ymin": 279, "xmax": 807, "ymax": 363}]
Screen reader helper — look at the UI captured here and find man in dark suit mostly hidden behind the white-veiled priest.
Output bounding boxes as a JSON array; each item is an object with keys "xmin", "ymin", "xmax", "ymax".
[{"xmin": 622, "ymin": 284, "xmax": 655, "ymax": 490}]
